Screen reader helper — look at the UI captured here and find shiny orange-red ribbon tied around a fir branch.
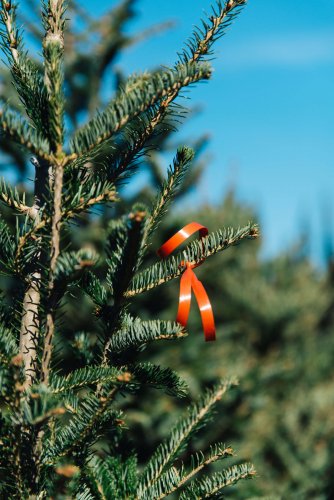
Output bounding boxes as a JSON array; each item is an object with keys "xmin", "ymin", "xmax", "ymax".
[{"xmin": 158, "ymin": 222, "xmax": 216, "ymax": 342}]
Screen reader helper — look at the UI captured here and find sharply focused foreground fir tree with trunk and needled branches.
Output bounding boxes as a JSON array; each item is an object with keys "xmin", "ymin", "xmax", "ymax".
[{"xmin": 0, "ymin": 0, "xmax": 257, "ymax": 500}]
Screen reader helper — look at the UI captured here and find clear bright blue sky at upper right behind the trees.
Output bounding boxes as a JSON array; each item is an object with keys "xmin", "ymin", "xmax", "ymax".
[{"xmin": 88, "ymin": 0, "xmax": 334, "ymax": 262}]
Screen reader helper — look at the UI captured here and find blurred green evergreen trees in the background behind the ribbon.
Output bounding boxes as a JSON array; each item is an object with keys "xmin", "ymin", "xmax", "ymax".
[{"xmin": 132, "ymin": 191, "xmax": 334, "ymax": 500}]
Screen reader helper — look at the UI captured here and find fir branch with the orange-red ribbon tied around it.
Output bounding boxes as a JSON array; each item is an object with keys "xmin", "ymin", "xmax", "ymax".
[{"xmin": 125, "ymin": 223, "xmax": 259, "ymax": 297}]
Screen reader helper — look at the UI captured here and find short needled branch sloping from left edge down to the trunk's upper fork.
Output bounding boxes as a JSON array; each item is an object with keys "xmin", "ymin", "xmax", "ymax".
[{"xmin": 0, "ymin": 104, "xmax": 49, "ymax": 160}]
